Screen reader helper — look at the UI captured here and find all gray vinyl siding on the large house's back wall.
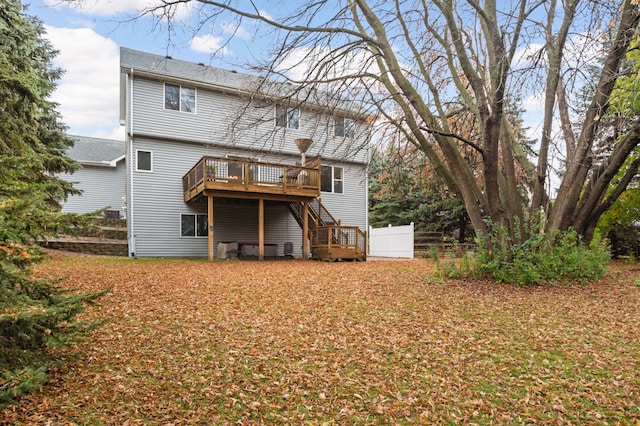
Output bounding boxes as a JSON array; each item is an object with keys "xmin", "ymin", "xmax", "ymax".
[{"xmin": 126, "ymin": 70, "xmax": 368, "ymax": 257}]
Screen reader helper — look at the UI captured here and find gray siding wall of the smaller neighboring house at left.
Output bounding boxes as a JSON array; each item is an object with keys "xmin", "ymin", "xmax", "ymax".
[{"xmin": 60, "ymin": 160, "xmax": 125, "ymax": 213}]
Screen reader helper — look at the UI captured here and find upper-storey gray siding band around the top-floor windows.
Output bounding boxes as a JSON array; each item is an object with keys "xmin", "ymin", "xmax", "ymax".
[{"xmin": 132, "ymin": 78, "xmax": 368, "ymax": 163}]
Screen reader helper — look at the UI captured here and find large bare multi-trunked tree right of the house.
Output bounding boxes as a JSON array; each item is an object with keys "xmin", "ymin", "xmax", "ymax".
[{"xmin": 140, "ymin": 0, "xmax": 640, "ymax": 251}]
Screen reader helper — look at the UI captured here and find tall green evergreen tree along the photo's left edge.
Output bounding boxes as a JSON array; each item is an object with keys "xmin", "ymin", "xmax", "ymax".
[{"xmin": 0, "ymin": 0, "xmax": 105, "ymax": 405}]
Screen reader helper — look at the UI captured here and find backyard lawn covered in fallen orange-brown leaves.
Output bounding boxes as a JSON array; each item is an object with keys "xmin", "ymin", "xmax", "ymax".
[{"xmin": 3, "ymin": 255, "xmax": 640, "ymax": 424}]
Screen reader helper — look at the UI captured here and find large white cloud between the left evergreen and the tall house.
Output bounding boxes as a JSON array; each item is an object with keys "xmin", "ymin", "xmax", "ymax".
[{"xmin": 45, "ymin": 26, "xmax": 120, "ymax": 136}]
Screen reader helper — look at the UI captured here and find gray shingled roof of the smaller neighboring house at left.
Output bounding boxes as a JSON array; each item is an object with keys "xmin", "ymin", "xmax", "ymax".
[{"xmin": 67, "ymin": 135, "xmax": 125, "ymax": 167}]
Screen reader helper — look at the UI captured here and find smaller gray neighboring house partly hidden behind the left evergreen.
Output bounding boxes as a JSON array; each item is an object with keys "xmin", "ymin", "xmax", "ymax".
[{"xmin": 60, "ymin": 136, "xmax": 126, "ymax": 217}]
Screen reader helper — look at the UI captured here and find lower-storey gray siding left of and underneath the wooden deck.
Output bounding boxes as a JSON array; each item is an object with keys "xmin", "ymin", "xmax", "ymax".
[{"xmin": 129, "ymin": 139, "xmax": 302, "ymax": 257}]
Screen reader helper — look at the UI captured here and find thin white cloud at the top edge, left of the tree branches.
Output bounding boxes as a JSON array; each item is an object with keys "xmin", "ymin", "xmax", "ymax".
[{"xmin": 44, "ymin": 0, "xmax": 194, "ymax": 20}]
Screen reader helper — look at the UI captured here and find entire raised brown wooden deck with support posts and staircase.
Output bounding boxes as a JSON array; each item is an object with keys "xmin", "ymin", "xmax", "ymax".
[{"xmin": 182, "ymin": 157, "xmax": 367, "ymax": 261}]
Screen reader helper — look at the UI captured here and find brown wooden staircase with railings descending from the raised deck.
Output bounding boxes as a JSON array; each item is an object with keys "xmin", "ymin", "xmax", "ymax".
[{"xmin": 289, "ymin": 198, "xmax": 367, "ymax": 261}]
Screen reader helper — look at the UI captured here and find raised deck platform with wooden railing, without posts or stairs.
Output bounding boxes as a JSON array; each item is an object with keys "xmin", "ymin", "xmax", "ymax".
[{"xmin": 182, "ymin": 157, "xmax": 320, "ymax": 203}]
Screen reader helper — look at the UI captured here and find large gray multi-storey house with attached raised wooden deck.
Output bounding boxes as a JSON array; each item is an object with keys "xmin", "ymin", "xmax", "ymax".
[{"xmin": 120, "ymin": 48, "xmax": 369, "ymax": 259}]
